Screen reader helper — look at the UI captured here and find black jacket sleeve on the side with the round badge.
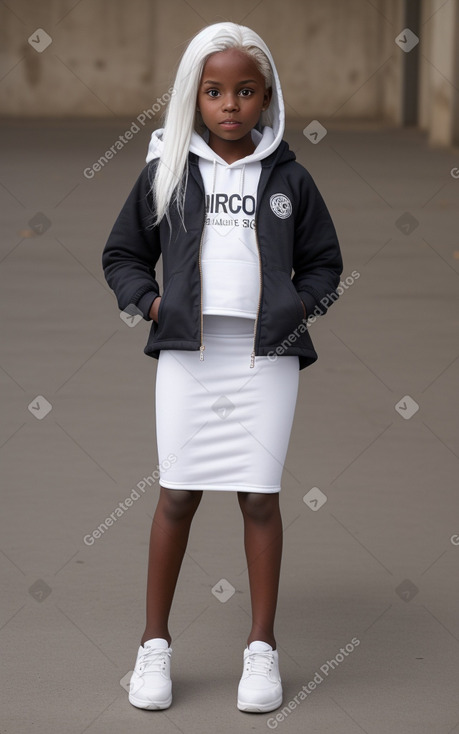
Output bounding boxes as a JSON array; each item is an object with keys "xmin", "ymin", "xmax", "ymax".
[{"xmin": 292, "ymin": 169, "xmax": 343, "ymax": 317}]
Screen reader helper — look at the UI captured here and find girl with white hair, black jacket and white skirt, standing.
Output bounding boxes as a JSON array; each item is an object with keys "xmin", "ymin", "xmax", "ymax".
[{"xmin": 103, "ymin": 23, "xmax": 342, "ymax": 712}]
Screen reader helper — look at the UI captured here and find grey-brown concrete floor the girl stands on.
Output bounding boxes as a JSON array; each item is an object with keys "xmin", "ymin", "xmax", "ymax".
[{"xmin": 0, "ymin": 119, "xmax": 459, "ymax": 734}]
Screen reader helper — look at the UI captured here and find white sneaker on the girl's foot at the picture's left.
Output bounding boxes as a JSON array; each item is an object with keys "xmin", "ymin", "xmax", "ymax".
[{"xmin": 129, "ymin": 637, "xmax": 172, "ymax": 709}]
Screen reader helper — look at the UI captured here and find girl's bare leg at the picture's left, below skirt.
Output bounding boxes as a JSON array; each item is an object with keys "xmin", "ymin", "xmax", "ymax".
[{"xmin": 140, "ymin": 487, "xmax": 202, "ymax": 645}]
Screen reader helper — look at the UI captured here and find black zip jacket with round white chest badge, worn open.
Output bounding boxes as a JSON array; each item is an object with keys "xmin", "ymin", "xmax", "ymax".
[{"xmin": 102, "ymin": 141, "xmax": 343, "ymax": 369}]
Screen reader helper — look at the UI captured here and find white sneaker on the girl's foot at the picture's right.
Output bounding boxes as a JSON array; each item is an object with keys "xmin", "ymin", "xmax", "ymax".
[{"xmin": 237, "ymin": 640, "xmax": 282, "ymax": 713}]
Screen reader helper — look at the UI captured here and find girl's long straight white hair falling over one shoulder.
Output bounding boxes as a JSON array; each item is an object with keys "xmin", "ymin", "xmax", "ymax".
[{"xmin": 152, "ymin": 22, "xmax": 273, "ymax": 224}]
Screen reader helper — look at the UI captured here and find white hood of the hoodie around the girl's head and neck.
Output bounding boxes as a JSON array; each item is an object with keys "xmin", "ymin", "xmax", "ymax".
[{"xmin": 146, "ymin": 42, "xmax": 285, "ymax": 168}]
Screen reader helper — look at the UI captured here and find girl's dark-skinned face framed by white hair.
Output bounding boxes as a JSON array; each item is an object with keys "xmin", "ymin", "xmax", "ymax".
[{"xmin": 197, "ymin": 48, "xmax": 271, "ymax": 158}]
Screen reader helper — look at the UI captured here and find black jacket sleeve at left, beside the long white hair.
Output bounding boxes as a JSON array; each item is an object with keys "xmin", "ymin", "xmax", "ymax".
[{"xmin": 102, "ymin": 165, "xmax": 161, "ymax": 321}]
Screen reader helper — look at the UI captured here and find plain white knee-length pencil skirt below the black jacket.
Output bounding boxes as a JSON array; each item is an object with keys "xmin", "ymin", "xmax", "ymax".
[{"xmin": 155, "ymin": 315, "xmax": 299, "ymax": 493}]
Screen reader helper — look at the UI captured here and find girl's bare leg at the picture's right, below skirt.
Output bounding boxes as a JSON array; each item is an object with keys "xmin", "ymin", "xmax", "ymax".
[{"xmin": 238, "ymin": 492, "xmax": 283, "ymax": 650}]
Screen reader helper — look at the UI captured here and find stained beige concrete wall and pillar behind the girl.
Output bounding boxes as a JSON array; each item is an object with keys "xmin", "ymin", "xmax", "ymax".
[{"xmin": 0, "ymin": 0, "xmax": 459, "ymax": 143}]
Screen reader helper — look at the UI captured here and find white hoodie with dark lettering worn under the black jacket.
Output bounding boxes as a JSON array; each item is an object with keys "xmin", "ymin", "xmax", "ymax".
[{"xmin": 146, "ymin": 49, "xmax": 285, "ymax": 319}]
